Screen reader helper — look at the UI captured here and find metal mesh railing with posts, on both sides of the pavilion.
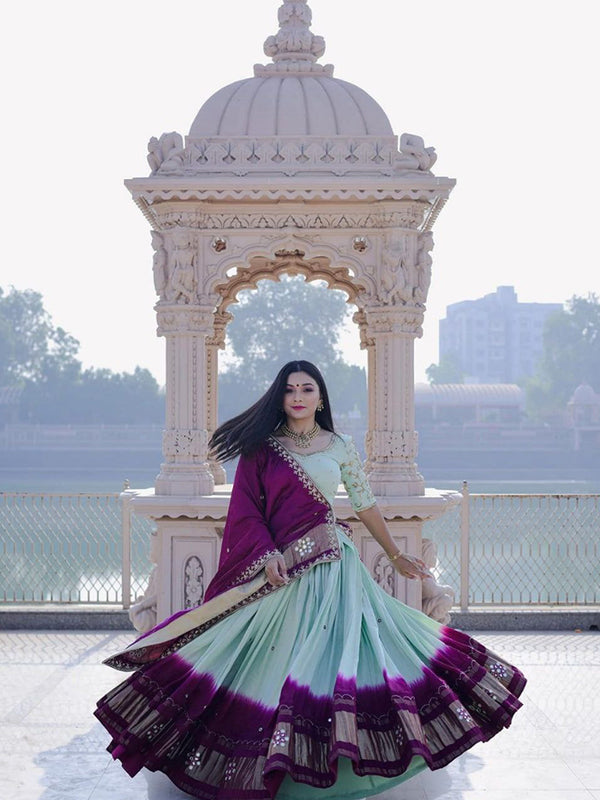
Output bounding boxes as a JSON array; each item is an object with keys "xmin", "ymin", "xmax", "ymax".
[{"xmin": 0, "ymin": 484, "xmax": 600, "ymax": 610}]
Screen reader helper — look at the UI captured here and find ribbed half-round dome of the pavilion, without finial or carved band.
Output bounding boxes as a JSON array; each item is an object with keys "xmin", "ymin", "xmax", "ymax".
[{"xmin": 190, "ymin": 73, "xmax": 394, "ymax": 139}]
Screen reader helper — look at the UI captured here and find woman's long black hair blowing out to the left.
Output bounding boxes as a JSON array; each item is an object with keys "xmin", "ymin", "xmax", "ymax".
[{"xmin": 208, "ymin": 361, "xmax": 335, "ymax": 461}]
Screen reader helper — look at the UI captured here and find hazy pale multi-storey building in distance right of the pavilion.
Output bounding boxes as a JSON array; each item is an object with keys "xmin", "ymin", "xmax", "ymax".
[{"xmin": 439, "ymin": 286, "xmax": 562, "ymax": 383}]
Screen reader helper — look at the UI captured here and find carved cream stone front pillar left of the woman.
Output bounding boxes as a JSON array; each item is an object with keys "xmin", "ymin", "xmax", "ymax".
[{"xmin": 156, "ymin": 302, "xmax": 214, "ymax": 495}]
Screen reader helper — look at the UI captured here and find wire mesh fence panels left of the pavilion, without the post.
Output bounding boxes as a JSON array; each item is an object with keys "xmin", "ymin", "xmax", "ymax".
[{"xmin": 0, "ymin": 492, "xmax": 152, "ymax": 604}]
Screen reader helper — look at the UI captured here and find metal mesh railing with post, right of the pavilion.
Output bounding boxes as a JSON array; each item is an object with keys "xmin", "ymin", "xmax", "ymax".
[{"xmin": 423, "ymin": 483, "xmax": 600, "ymax": 610}]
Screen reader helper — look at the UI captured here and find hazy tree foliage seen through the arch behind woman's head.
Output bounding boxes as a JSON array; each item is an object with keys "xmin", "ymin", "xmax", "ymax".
[{"xmin": 219, "ymin": 276, "xmax": 366, "ymax": 421}]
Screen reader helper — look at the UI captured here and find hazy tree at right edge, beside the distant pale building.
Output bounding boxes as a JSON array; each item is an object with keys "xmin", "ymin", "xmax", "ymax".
[{"xmin": 526, "ymin": 293, "xmax": 600, "ymax": 420}]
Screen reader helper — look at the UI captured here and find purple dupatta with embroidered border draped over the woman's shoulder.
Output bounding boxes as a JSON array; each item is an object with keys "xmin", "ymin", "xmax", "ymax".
[{"xmin": 104, "ymin": 436, "xmax": 341, "ymax": 671}]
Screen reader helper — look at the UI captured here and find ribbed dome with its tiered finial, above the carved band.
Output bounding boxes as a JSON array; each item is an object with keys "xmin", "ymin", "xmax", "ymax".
[{"xmin": 190, "ymin": 0, "xmax": 394, "ymax": 139}]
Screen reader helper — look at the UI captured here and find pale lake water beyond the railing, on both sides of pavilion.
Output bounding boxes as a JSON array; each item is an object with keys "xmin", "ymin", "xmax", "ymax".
[{"xmin": 0, "ymin": 461, "xmax": 600, "ymax": 603}]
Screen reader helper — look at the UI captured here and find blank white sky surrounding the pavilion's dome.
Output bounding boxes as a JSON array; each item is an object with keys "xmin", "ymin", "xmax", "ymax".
[{"xmin": 0, "ymin": 0, "xmax": 600, "ymax": 382}]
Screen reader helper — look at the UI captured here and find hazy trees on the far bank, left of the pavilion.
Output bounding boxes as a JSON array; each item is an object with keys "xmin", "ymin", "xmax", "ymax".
[{"xmin": 0, "ymin": 288, "xmax": 164, "ymax": 424}]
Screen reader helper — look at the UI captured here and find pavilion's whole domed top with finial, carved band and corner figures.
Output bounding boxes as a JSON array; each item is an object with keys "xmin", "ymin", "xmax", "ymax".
[{"xmin": 141, "ymin": 0, "xmax": 436, "ymax": 183}]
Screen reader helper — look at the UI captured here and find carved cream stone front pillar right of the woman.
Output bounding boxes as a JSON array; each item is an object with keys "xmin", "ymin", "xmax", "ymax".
[{"xmin": 364, "ymin": 305, "xmax": 425, "ymax": 497}]
